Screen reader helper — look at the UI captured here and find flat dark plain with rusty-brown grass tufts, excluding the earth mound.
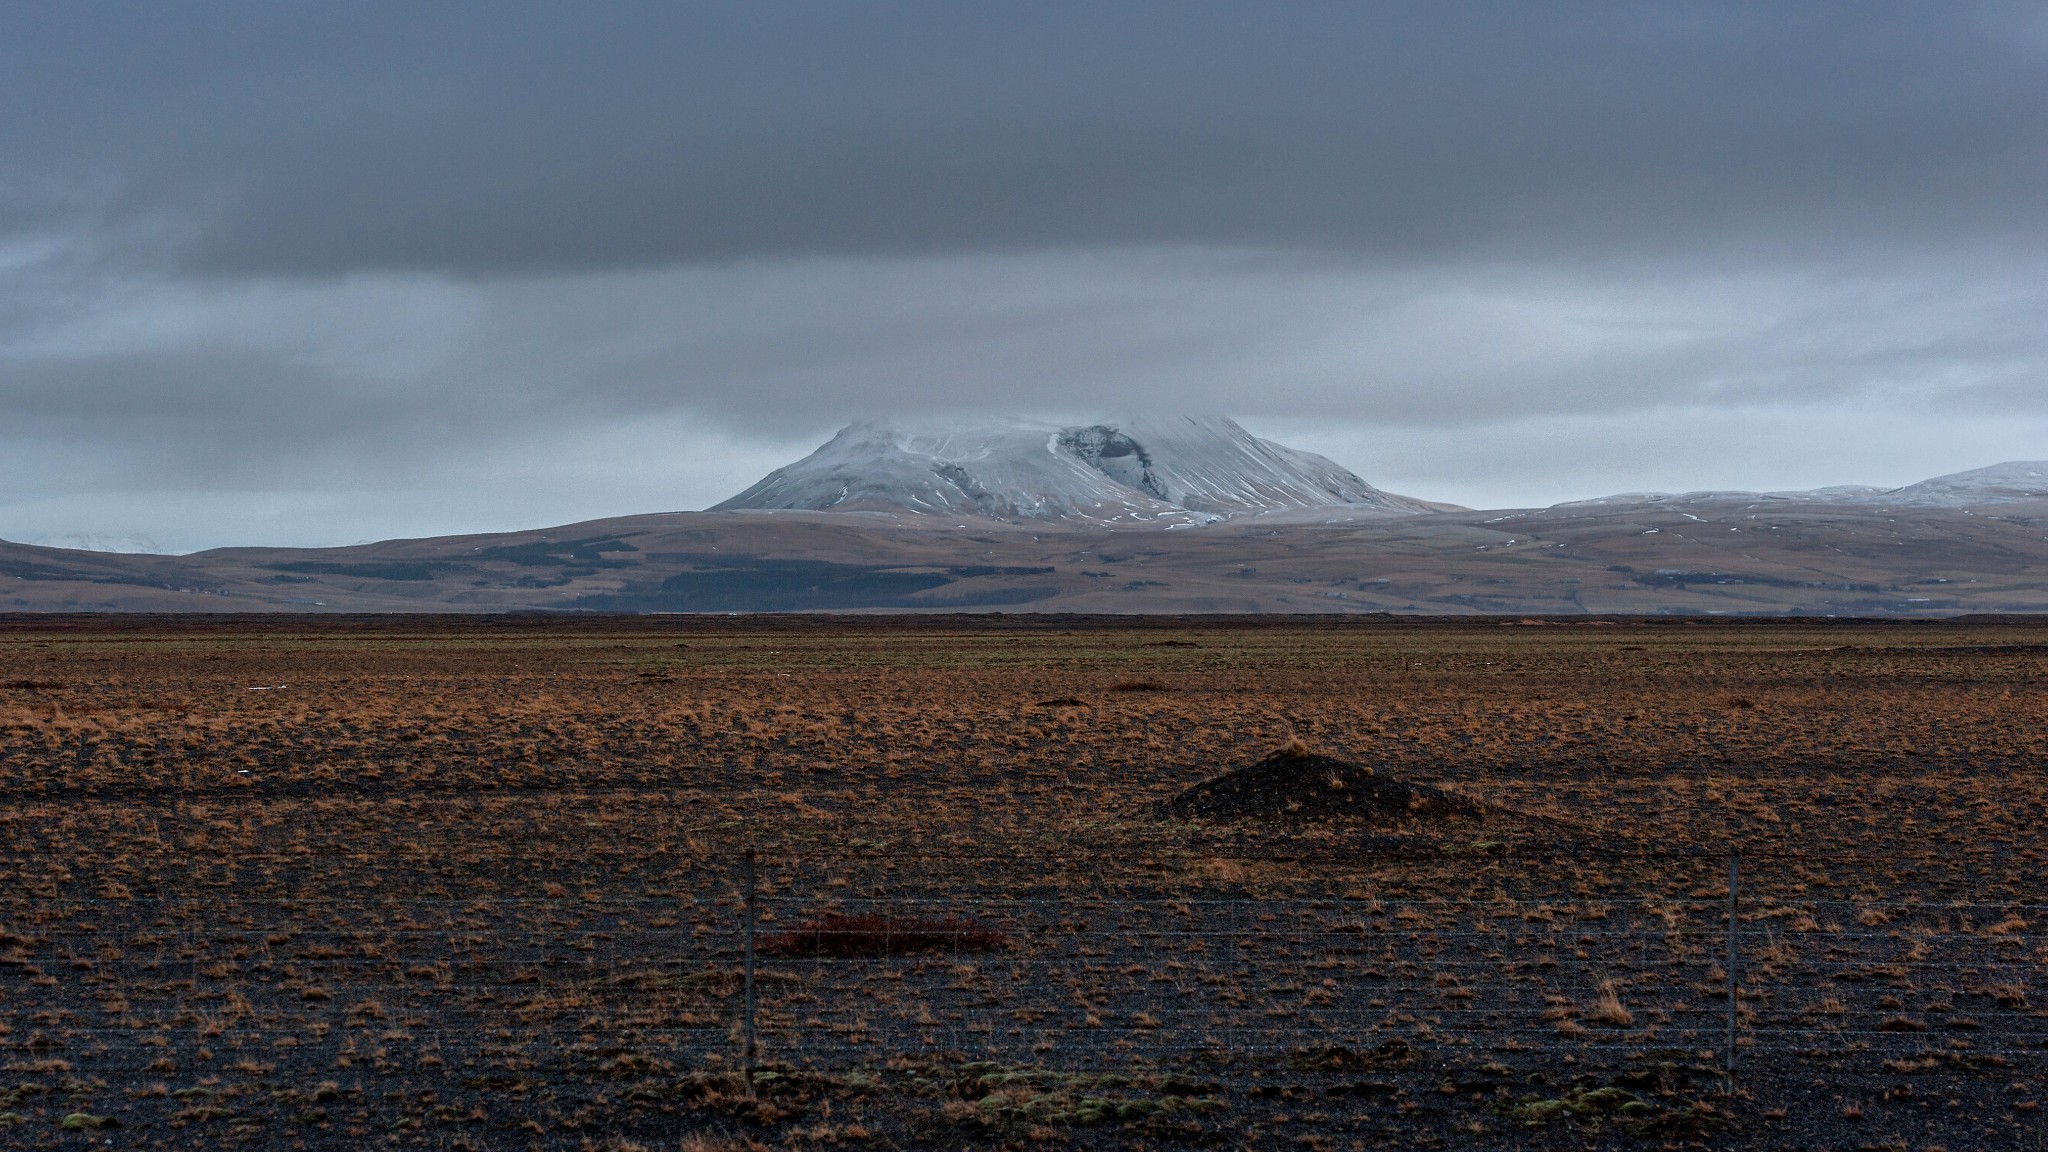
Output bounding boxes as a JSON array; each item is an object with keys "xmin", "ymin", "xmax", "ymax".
[{"xmin": 0, "ymin": 617, "xmax": 2048, "ymax": 1148}]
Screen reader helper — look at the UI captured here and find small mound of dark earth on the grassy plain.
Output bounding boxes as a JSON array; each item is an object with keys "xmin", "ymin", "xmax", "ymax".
[{"xmin": 1165, "ymin": 744, "xmax": 1481, "ymax": 824}]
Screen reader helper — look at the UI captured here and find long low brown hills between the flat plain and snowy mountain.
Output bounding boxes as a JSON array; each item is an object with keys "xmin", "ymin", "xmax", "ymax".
[{"xmin": 0, "ymin": 494, "xmax": 2048, "ymax": 615}]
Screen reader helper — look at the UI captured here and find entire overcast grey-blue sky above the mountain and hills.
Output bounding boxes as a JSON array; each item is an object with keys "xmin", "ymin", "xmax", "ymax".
[{"xmin": 0, "ymin": 0, "xmax": 2048, "ymax": 551}]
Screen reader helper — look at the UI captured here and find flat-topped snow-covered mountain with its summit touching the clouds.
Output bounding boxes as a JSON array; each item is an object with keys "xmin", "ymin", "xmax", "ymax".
[{"xmin": 713, "ymin": 416, "xmax": 1442, "ymax": 527}]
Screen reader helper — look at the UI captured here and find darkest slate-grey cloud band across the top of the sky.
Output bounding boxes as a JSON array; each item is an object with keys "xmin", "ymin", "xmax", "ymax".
[{"xmin": 0, "ymin": 0, "xmax": 2048, "ymax": 275}]
